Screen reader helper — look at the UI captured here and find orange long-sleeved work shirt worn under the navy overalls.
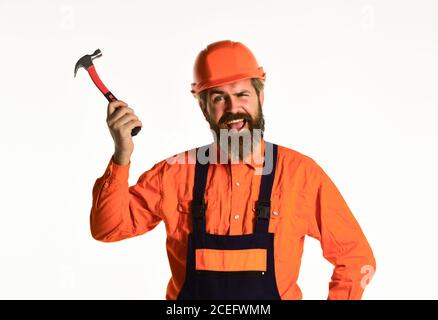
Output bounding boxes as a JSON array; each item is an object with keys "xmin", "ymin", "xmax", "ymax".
[{"xmin": 90, "ymin": 141, "xmax": 375, "ymax": 300}]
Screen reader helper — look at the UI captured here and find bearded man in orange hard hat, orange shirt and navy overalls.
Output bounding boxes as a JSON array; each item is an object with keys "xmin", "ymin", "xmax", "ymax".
[{"xmin": 91, "ymin": 41, "xmax": 375, "ymax": 299}]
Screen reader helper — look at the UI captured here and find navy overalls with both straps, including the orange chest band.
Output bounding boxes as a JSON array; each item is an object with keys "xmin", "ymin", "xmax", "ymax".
[{"xmin": 177, "ymin": 142, "xmax": 281, "ymax": 300}]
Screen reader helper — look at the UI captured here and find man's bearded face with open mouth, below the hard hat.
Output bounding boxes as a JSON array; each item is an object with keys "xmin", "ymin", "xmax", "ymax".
[{"xmin": 200, "ymin": 79, "xmax": 264, "ymax": 160}]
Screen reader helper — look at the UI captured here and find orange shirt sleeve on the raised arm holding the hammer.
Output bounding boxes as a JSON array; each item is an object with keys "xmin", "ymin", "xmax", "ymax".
[{"xmin": 90, "ymin": 157, "xmax": 163, "ymax": 242}]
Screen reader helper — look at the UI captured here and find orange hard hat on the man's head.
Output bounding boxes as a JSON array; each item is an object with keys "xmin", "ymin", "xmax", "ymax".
[{"xmin": 191, "ymin": 40, "xmax": 266, "ymax": 95}]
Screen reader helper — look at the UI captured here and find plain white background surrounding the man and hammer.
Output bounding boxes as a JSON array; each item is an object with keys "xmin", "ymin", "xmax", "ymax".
[{"xmin": 0, "ymin": 0, "xmax": 438, "ymax": 299}]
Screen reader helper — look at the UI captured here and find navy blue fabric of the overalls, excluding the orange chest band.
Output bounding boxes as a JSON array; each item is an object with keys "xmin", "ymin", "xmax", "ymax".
[{"xmin": 177, "ymin": 142, "xmax": 281, "ymax": 300}]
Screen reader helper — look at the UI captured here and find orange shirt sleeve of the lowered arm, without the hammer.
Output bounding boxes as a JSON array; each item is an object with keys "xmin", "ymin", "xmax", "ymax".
[{"xmin": 304, "ymin": 165, "xmax": 376, "ymax": 300}]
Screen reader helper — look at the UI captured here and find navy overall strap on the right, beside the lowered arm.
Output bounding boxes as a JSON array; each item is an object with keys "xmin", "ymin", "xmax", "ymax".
[{"xmin": 255, "ymin": 141, "xmax": 278, "ymax": 233}]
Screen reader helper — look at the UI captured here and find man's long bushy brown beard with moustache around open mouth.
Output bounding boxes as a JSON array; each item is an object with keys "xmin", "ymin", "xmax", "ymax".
[{"xmin": 208, "ymin": 102, "xmax": 265, "ymax": 163}]
